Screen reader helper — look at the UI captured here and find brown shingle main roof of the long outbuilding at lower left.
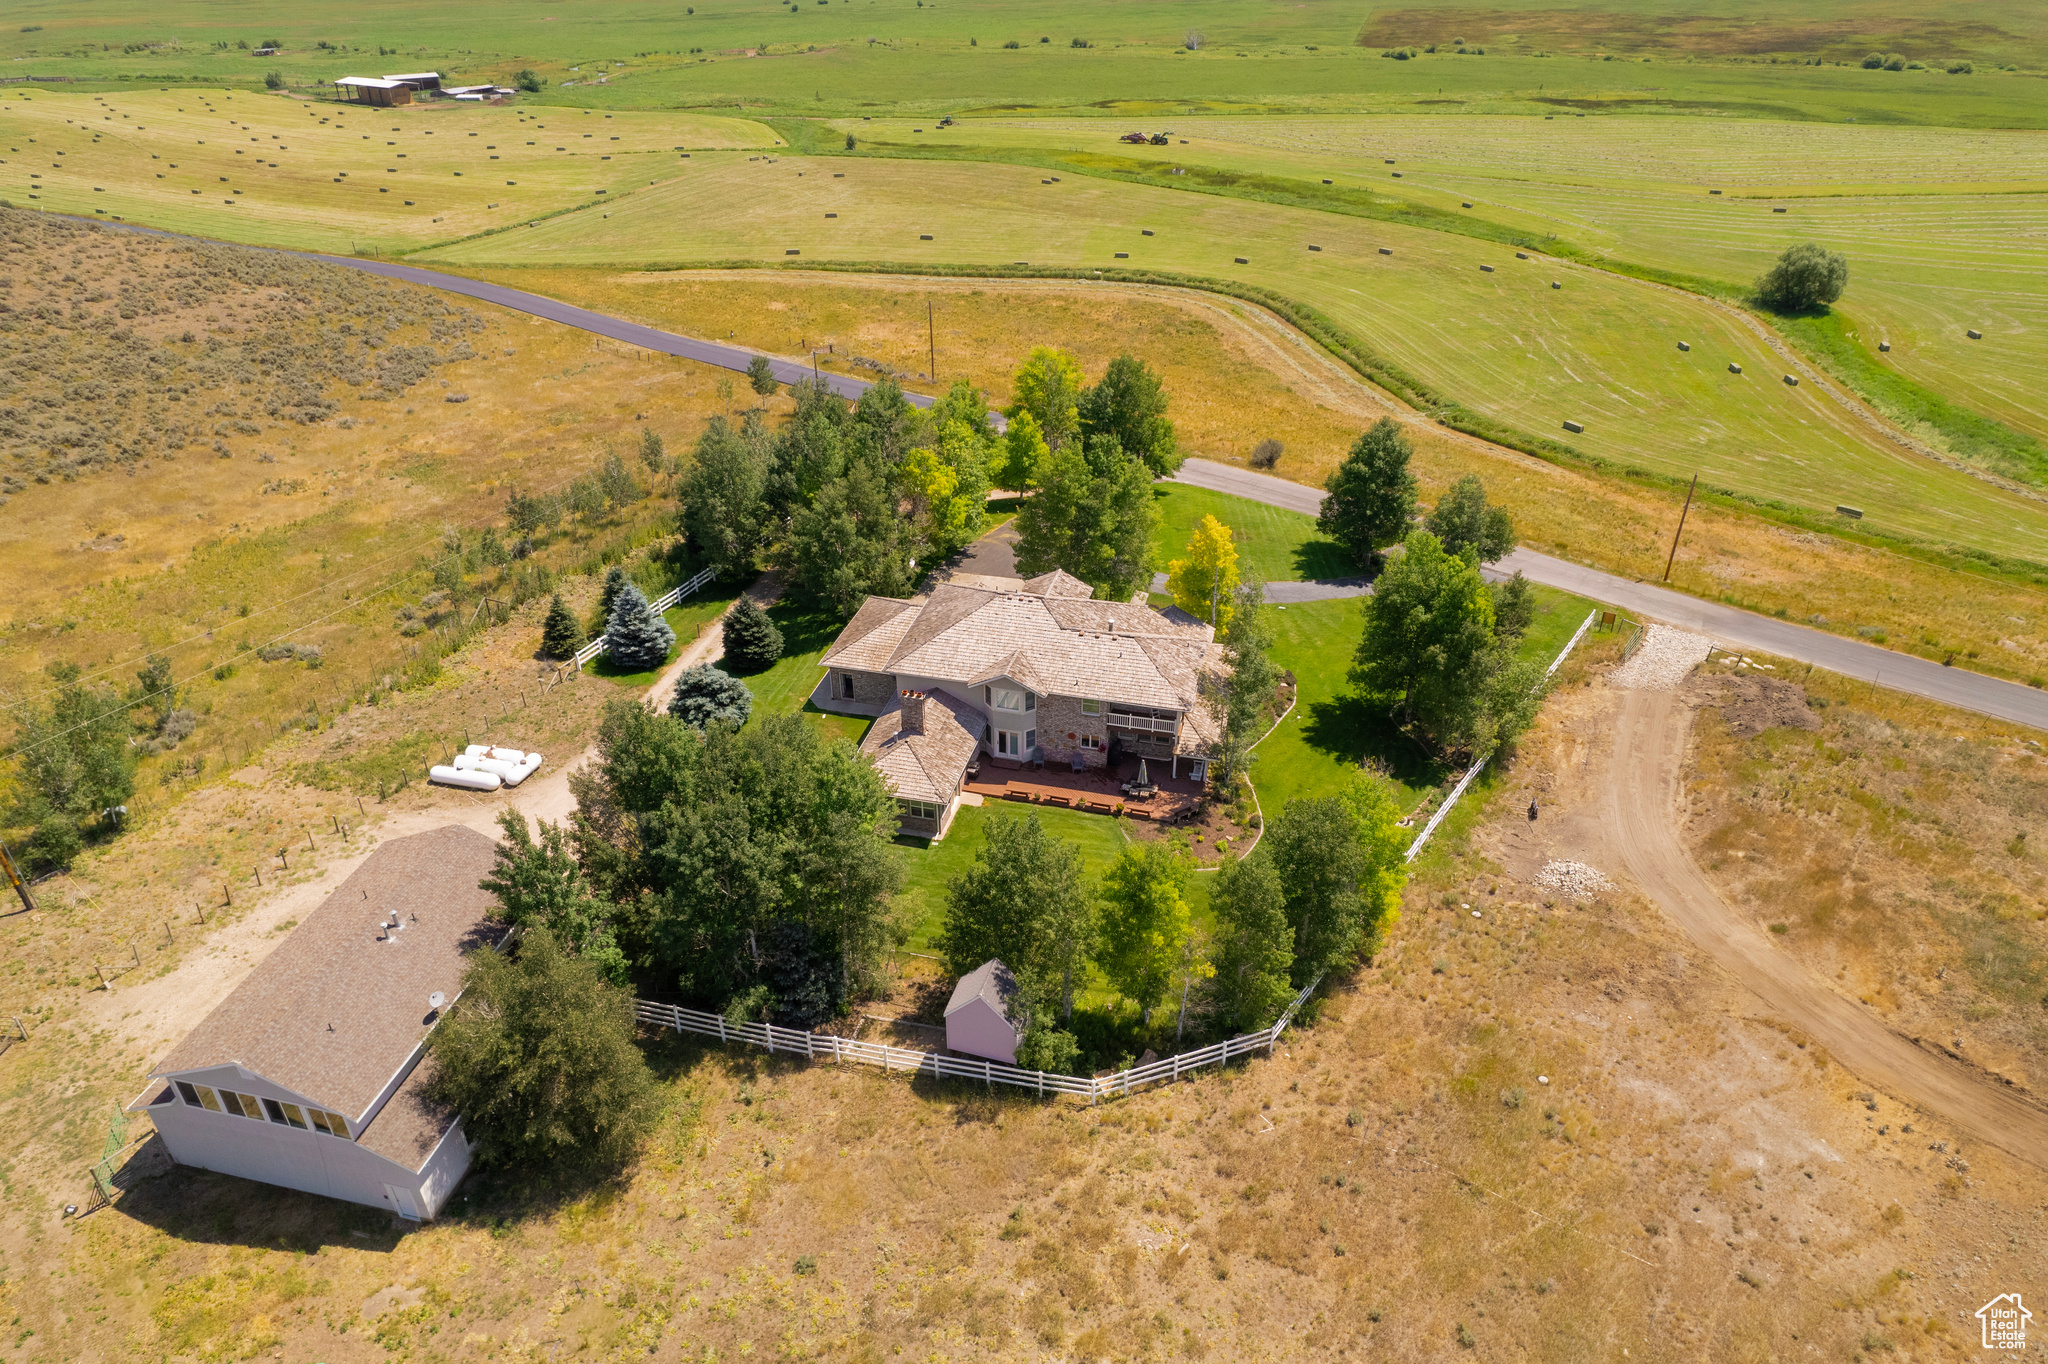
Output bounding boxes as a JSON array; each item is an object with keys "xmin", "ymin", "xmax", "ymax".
[{"xmin": 152, "ymin": 825, "xmax": 502, "ymax": 1126}]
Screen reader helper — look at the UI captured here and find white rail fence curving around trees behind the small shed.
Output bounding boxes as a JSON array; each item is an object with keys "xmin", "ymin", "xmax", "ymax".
[{"xmin": 633, "ymin": 977, "xmax": 1321, "ymax": 1104}]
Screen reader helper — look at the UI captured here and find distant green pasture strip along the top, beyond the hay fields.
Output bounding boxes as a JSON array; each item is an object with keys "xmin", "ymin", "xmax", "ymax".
[{"xmin": 12, "ymin": 0, "xmax": 2048, "ymax": 127}]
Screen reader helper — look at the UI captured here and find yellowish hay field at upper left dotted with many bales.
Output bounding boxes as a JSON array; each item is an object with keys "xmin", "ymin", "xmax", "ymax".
[{"xmin": 0, "ymin": 88, "xmax": 776, "ymax": 254}]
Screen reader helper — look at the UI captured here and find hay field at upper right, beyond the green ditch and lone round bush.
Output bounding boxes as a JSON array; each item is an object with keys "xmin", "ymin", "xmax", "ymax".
[{"xmin": 946, "ymin": 115, "xmax": 2048, "ymax": 446}]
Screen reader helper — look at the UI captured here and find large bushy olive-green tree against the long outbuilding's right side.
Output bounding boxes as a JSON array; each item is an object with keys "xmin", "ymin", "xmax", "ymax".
[{"xmin": 428, "ymin": 926, "xmax": 659, "ymax": 1169}]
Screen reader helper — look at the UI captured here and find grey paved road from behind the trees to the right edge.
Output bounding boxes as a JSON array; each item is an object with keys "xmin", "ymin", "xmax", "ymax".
[{"xmin": 1178, "ymin": 459, "xmax": 2048, "ymax": 729}]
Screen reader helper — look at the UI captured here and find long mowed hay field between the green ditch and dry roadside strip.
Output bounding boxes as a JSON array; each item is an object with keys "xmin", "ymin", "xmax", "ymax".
[{"xmin": 416, "ymin": 154, "xmax": 2048, "ymax": 557}]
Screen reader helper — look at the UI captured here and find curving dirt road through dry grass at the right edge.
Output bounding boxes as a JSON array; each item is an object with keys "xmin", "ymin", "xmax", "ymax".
[{"xmin": 1602, "ymin": 690, "xmax": 2048, "ymax": 1167}]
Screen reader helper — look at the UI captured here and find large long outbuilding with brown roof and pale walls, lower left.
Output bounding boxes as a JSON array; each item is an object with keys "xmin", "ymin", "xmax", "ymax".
[{"xmin": 131, "ymin": 825, "xmax": 506, "ymax": 1221}]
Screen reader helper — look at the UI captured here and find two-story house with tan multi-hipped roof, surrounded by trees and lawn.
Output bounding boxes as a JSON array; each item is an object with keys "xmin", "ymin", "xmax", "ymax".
[{"xmin": 811, "ymin": 569, "xmax": 1225, "ymax": 836}]
